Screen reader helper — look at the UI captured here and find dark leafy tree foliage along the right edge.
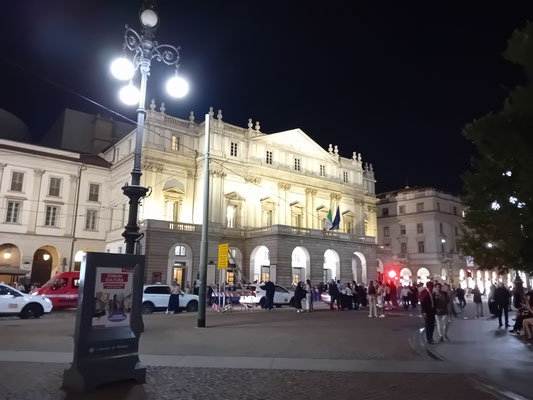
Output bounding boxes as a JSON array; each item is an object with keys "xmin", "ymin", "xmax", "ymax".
[{"xmin": 461, "ymin": 24, "xmax": 533, "ymax": 273}]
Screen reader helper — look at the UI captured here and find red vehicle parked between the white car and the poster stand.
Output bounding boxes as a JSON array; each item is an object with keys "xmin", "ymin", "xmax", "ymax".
[{"xmin": 30, "ymin": 271, "xmax": 80, "ymax": 309}]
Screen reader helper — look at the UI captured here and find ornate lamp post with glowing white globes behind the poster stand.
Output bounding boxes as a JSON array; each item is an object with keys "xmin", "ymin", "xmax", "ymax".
[{"xmin": 111, "ymin": 0, "xmax": 189, "ymax": 254}]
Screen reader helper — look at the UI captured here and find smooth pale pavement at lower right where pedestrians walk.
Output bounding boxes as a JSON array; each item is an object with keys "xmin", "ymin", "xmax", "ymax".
[{"xmin": 424, "ymin": 303, "xmax": 533, "ymax": 398}]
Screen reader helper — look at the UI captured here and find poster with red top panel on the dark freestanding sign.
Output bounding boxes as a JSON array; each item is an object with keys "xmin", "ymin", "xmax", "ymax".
[{"xmin": 92, "ymin": 267, "xmax": 133, "ymax": 329}]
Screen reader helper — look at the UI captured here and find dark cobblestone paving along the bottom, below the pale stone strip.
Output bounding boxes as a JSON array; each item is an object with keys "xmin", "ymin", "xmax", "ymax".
[{"xmin": 0, "ymin": 363, "xmax": 501, "ymax": 400}]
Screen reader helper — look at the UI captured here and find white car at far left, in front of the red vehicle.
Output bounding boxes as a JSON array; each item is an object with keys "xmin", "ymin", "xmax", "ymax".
[{"xmin": 0, "ymin": 283, "xmax": 52, "ymax": 319}]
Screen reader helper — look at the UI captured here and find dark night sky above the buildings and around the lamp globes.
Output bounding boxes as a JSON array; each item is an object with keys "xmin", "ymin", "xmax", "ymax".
[{"xmin": 0, "ymin": 0, "xmax": 533, "ymax": 192}]
